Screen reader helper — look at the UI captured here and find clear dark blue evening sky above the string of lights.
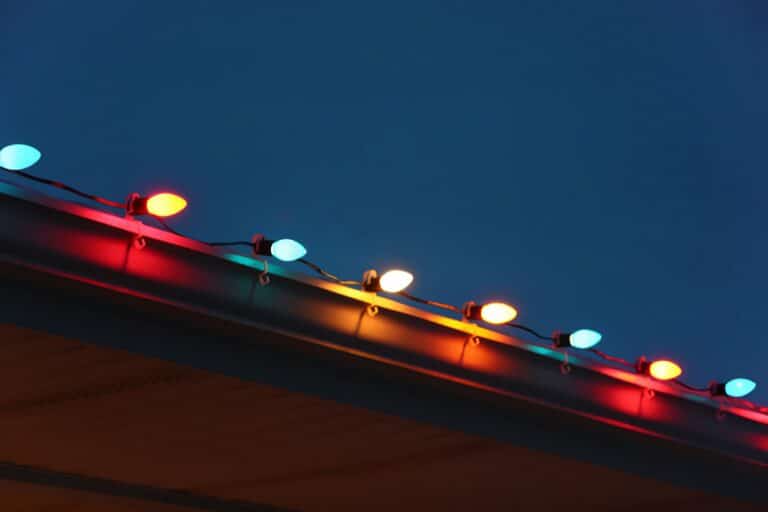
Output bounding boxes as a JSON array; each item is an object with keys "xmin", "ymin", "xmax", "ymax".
[{"xmin": 0, "ymin": 0, "xmax": 768, "ymax": 402}]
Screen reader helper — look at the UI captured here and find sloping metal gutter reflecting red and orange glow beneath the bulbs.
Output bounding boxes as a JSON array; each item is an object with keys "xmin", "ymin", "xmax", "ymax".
[{"xmin": 0, "ymin": 181, "xmax": 768, "ymax": 466}]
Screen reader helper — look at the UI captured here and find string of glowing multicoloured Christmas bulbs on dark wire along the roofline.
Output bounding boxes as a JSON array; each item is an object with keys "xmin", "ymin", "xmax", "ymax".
[{"xmin": 0, "ymin": 144, "xmax": 768, "ymax": 408}]
